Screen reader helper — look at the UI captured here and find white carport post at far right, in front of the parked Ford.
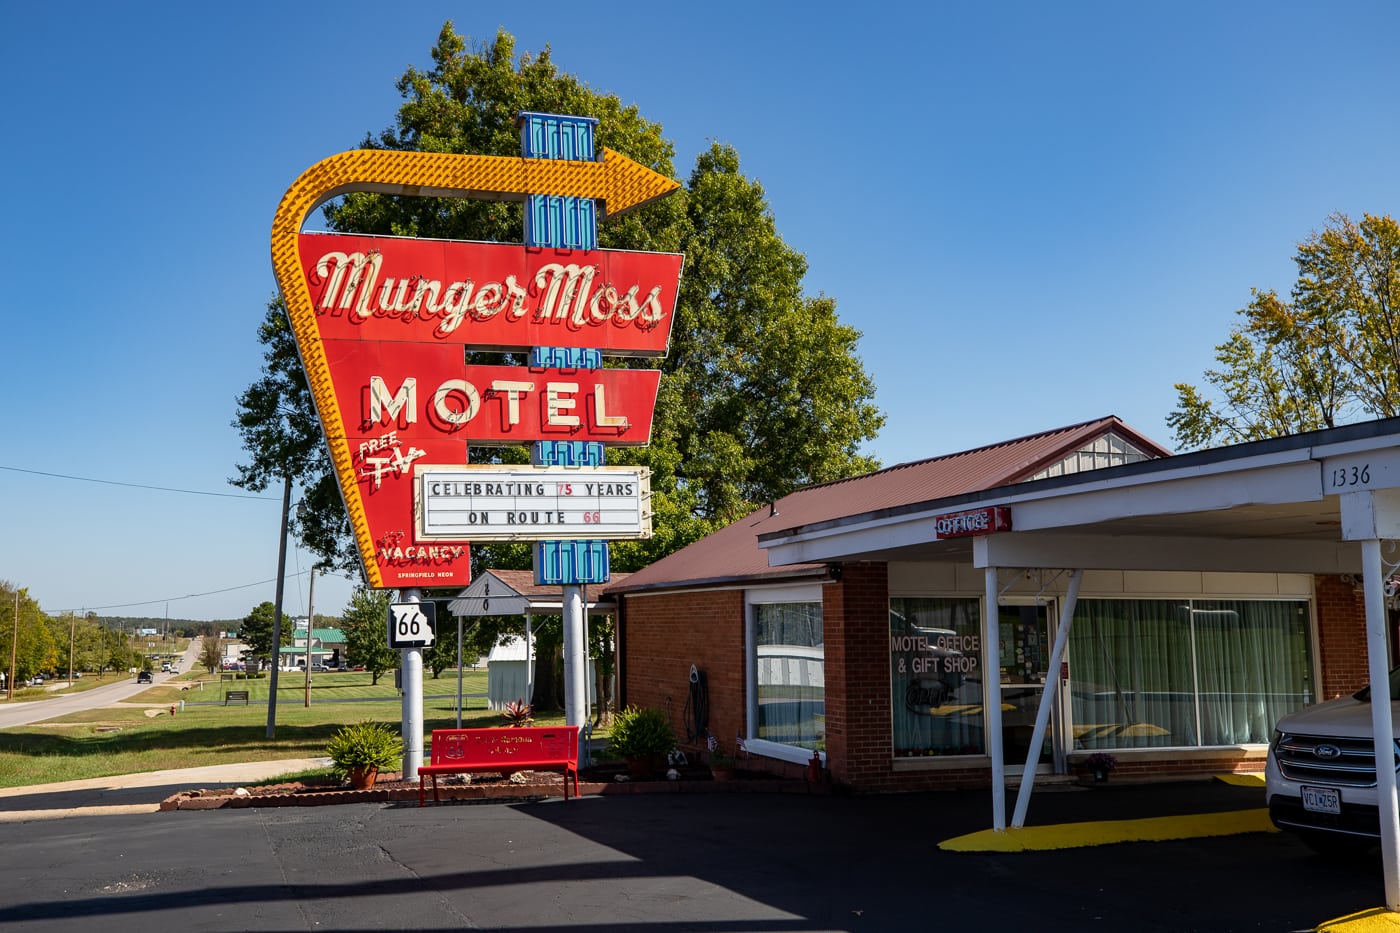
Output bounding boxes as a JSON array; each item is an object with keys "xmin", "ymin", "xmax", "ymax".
[{"xmin": 1361, "ymin": 538, "xmax": 1400, "ymax": 911}]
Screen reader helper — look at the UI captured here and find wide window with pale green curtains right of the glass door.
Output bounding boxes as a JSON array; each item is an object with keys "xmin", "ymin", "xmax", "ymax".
[{"xmin": 1070, "ymin": 600, "xmax": 1315, "ymax": 748}]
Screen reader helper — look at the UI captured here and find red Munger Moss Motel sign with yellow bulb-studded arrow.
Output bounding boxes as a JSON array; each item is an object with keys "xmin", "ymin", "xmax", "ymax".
[{"xmin": 272, "ymin": 150, "xmax": 680, "ymax": 588}]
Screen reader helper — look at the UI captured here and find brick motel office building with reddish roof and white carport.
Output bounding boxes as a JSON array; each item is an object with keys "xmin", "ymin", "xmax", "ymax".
[{"xmin": 603, "ymin": 416, "xmax": 1400, "ymax": 793}]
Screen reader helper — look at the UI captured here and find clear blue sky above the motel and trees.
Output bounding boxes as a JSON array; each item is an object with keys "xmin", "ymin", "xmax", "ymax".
[{"xmin": 0, "ymin": 0, "xmax": 1400, "ymax": 619}]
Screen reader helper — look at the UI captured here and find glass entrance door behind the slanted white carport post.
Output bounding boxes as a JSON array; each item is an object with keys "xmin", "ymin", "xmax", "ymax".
[{"xmin": 997, "ymin": 600, "xmax": 1064, "ymax": 773}]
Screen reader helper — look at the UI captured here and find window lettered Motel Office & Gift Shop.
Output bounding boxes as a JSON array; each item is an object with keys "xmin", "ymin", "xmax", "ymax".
[{"xmin": 889, "ymin": 597, "xmax": 986, "ymax": 758}]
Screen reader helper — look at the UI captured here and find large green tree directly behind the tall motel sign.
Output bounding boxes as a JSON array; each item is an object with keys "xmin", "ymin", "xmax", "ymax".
[{"xmin": 235, "ymin": 22, "xmax": 883, "ymax": 570}]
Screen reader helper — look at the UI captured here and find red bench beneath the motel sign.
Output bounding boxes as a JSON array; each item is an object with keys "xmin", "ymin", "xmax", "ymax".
[{"xmin": 419, "ymin": 726, "xmax": 578, "ymax": 807}]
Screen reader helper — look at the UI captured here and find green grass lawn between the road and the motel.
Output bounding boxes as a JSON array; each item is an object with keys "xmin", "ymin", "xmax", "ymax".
[{"xmin": 0, "ymin": 671, "xmax": 564, "ymax": 787}]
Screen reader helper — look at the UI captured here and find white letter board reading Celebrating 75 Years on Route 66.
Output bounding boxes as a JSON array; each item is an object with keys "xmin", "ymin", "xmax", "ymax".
[{"xmin": 416, "ymin": 465, "xmax": 651, "ymax": 541}]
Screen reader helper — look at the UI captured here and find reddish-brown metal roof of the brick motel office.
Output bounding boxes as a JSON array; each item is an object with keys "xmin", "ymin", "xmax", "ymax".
[{"xmin": 605, "ymin": 415, "xmax": 1172, "ymax": 593}]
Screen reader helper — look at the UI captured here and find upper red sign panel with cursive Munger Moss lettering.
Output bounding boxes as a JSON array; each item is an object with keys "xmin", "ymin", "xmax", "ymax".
[{"xmin": 297, "ymin": 234, "xmax": 682, "ymax": 356}]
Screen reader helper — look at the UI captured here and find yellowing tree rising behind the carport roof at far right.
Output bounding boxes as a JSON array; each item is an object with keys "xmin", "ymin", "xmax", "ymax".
[{"xmin": 1166, "ymin": 214, "xmax": 1400, "ymax": 448}]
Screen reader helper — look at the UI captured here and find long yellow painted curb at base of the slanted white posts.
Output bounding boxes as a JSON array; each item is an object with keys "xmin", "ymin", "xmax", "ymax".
[{"xmin": 938, "ymin": 810, "xmax": 1278, "ymax": 852}]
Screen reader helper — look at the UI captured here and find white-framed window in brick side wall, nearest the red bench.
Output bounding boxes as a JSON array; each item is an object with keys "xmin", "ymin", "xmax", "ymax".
[{"xmin": 753, "ymin": 602, "xmax": 826, "ymax": 749}]
